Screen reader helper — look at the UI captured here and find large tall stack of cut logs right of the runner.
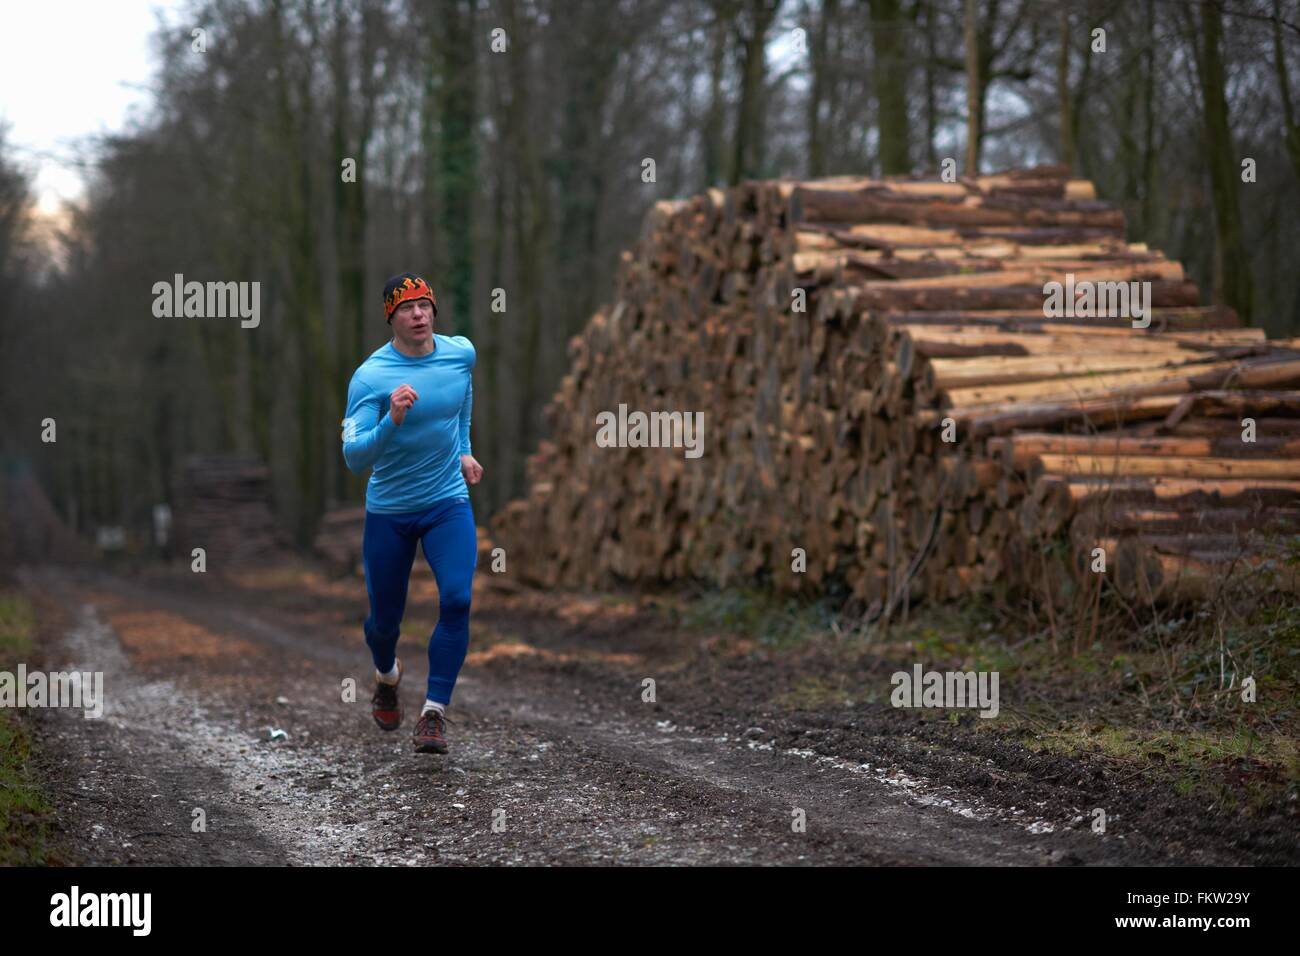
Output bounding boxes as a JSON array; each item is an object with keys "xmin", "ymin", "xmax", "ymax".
[{"xmin": 493, "ymin": 168, "xmax": 1300, "ymax": 611}]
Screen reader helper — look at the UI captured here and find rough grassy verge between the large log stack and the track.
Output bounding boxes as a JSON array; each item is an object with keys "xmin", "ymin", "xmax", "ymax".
[{"xmin": 650, "ymin": 589, "xmax": 1300, "ymax": 813}]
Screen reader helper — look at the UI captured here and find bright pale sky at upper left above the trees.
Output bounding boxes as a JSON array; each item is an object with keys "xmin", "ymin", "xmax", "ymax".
[{"xmin": 0, "ymin": 0, "xmax": 178, "ymax": 216}]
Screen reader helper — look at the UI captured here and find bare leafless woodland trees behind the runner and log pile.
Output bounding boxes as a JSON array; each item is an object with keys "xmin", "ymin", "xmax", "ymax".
[{"xmin": 0, "ymin": 0, "xmax": 1300, "ymax": 542}]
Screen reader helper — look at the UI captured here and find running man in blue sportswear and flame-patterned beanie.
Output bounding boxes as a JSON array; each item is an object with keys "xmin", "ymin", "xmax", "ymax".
[{"xmin": 343, "ymin": 272, "xmax": 484, "ymax": 753}]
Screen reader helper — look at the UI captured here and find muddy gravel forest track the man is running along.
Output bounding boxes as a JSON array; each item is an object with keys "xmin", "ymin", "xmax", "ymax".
[{"xmin": 20, "ymin": 566, "xmax": 1294, "ymax": 865}]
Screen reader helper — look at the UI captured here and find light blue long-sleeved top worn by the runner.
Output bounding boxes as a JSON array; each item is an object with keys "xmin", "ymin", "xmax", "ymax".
[{"xmin": 343, "ymin": 333, "xmax": 477, "ymax": 514}]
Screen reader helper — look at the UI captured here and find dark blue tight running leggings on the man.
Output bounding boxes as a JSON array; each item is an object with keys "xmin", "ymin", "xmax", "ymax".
[{"xmin": 361, "ymin": 497, "xmax": 478, "ymax": 704}]
